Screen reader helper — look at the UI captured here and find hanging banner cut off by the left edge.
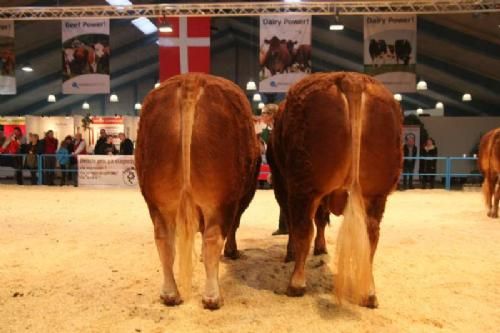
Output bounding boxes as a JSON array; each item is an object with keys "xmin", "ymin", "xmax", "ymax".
[{"xmin": 0, "ymin": 20, "xmax": 16, "ymax": 95}]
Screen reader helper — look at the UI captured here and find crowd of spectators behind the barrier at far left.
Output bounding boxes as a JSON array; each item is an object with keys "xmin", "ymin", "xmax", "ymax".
[{"xmin": 0, "ymin": 127, "xmax": 134, "ymax": 186}]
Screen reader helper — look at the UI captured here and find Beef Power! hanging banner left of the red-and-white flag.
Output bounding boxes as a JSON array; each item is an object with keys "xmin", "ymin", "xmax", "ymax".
[{"xmin": 62, "ymin": 19, "xmax": 110, "ymax": 94}]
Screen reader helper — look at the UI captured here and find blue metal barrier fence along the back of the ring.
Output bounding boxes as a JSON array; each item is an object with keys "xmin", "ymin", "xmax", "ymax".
[{"xmin": 0, "ymin": 154, "xmax": 482, "ymax": 190}]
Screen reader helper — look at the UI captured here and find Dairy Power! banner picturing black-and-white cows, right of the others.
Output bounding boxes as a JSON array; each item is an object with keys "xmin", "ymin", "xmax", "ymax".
[{"xmin": 364, "ymin": 15, "xmax": 417, "ymax": 93}]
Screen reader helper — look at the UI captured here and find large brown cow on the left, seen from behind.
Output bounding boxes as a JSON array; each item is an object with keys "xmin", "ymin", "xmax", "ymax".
[{"xmin": 135, "ymin": 74, "xmax": 260, "ymax": 309}]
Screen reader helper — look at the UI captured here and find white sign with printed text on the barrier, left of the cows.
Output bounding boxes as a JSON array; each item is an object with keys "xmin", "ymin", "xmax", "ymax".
[{"xmin": 78, "ymin": 155, "xmax": 138, "ymax": 187}]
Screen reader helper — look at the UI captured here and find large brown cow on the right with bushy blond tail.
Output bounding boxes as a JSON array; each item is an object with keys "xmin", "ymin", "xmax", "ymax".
[{"xmin": 268, "ymin": 72, "xmax": 402, "ymax": 307}]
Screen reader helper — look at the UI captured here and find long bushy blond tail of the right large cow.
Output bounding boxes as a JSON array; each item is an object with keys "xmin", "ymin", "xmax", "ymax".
[{"xmin": 335, "ymin": 78, "xmax": 372, "ymax": 304}]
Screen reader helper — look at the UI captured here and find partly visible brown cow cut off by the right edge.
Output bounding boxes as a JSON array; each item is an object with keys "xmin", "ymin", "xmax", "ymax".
[{"xmin": 478, "ymin": 128, "xmax": 500, "ymax": 218}]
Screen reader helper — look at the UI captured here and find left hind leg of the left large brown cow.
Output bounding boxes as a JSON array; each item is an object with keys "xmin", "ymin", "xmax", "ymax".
[{"xmin": 150, "ymin": 209, "xmax": 182, "ymax": 306}]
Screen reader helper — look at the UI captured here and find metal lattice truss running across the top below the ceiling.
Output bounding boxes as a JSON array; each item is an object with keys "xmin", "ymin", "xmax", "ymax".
[{"xmin": 0, "ymin": 0, "xmax": 500, "ymax": 20}]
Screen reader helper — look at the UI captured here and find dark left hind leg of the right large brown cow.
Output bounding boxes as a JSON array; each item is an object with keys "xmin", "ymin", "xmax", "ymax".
[{"xmin": 287, "ymin": 198, "xmax": 318, "ymax": 297}]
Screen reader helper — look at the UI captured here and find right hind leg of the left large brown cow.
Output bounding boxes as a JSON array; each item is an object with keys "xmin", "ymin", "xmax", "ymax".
[{"xmin": 202, "ymin": 206, "xmax": 236, "ymax": 310}]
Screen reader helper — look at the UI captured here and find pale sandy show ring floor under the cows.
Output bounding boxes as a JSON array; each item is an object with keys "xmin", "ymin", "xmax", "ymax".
[{"xmin": 0, "ymin": 186, "xmax": 500, "ymax": 333}]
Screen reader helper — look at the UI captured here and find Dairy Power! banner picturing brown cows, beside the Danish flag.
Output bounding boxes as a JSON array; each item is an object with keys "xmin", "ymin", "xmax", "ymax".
[{"xmin": 259, "ymin": 15, "xmax": 311, "ymax": 93}]
